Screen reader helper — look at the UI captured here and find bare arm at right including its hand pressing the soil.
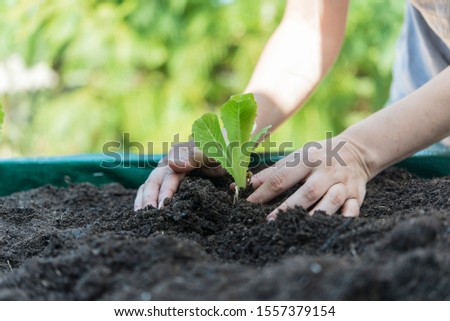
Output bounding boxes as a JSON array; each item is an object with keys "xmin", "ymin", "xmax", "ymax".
[{"xmin": 248, "ymin": 67, "xmax": 450, "ymax": 219}]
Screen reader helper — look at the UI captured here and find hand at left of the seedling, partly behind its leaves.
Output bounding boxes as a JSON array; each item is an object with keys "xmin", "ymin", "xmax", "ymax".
[{"xmin": 134, "ymin": 141, "xmax": 225, "ymax": 211}]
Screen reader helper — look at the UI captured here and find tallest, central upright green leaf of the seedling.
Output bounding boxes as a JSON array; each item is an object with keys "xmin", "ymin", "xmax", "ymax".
[{"xmin": 220, "ymin": 94, "xmax": 257, "ymax": 188}]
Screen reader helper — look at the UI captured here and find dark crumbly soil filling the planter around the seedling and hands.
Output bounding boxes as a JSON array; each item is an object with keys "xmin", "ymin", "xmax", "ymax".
[{"xmin": 0, "ymin": 169, "xmax": 450, "ymax": 300}]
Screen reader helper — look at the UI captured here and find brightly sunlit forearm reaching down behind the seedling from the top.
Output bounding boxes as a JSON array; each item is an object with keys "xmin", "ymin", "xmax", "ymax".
[{"xmin": 245, "ymin": 0, "xmax": 348, "ymax": 129}]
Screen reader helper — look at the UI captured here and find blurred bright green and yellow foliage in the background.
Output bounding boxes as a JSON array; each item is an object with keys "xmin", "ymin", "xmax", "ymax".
[{"xmin": 0, "ymin": 0, "xmax": 404, "ymax": 157}]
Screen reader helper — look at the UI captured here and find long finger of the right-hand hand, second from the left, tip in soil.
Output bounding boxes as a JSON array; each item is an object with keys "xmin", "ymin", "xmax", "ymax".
[{"xmin": 267, "ymin": 175, "xmax": 334, "ymax": 221}]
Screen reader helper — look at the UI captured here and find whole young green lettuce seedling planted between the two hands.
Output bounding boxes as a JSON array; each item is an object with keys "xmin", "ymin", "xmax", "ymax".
[{"xmin": 192, "ymin": 94, "xmax": 271, "ymax": 200}]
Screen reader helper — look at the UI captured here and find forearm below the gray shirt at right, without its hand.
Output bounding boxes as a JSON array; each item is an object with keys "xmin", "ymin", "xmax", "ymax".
[{"xmin": 340, "ymin": 67, "xmax": 450, "ymax": 178}]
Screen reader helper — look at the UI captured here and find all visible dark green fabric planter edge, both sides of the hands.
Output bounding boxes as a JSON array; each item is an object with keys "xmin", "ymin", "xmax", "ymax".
[{"xmin": 0, "ymin": 149, "xmax": 450, "ymax": 195}]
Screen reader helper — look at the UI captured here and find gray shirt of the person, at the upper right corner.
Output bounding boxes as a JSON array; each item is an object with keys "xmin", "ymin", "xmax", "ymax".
[{"xmin": 387, "ymin": 0, "xmax": 450, "ymax": 105}]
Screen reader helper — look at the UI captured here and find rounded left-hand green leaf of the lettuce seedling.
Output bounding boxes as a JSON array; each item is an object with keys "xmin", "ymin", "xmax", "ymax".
[{"xmin": 192, "ymin": 113, "xmax": 234, "ymax": 177}]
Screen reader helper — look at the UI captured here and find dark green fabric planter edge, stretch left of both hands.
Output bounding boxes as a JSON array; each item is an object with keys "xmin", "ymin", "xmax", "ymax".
[{"xmin": 0, "ymin": 154, "xmax": 161, "ymax": 195}]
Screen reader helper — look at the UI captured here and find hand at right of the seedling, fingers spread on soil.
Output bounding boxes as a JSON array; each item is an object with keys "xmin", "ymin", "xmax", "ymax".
[{"xmin": 247, "ymin": 137, "xmax": 371, "ymax": 220}]
